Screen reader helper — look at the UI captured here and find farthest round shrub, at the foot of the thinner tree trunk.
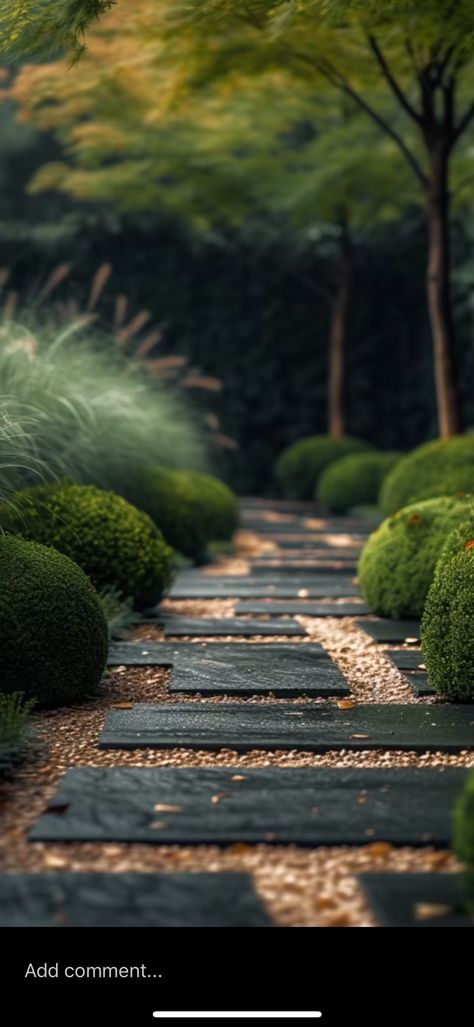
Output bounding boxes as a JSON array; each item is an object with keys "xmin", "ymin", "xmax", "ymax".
[{"xmin": 275, "ymin": 435, "xmax": 371, "ymax": 499}]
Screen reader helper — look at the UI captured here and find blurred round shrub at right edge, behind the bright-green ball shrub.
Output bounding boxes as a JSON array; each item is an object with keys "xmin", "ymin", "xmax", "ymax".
[{"xmin": 380, "ymin": 434, "xmax": 474, "ymax": 516}]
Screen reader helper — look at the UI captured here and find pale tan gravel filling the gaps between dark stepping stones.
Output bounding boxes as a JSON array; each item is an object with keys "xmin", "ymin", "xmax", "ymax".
[{"xmin": 0, "ymin": 514, "xmax": 474, "ymax": 927}]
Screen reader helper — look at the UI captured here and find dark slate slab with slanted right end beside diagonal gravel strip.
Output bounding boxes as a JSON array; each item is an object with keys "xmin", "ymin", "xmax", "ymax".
[{"xmin": 170, "ymin": 643, "xmax": 350, "ymax": 698}]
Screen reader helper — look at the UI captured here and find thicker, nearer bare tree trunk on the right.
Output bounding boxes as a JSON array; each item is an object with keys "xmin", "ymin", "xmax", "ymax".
[{"xmin": 427, "ymin": 143, "xmax": 462, "ymax": 439}]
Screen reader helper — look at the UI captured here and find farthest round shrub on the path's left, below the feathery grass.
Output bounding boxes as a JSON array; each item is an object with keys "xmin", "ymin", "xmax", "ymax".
[{"xmin": 128, "ymin": 467, "xmax": 237, "ymax": 561}]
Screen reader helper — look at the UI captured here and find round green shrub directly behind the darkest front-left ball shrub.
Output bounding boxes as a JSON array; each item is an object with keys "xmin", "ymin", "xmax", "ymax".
[{"xmin": 0, "ymin": 484, "xmax": 171, "ymax": 609}]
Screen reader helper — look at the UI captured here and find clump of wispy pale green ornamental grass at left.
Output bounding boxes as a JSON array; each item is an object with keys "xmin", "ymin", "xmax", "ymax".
[{"xmin": 0, "ymin": 318, "xmax": 205, "ymax": 492}]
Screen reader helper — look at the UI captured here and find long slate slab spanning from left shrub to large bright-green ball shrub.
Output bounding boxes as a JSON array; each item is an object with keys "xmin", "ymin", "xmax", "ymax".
[{"xmin": 168, "ymin": 574, "xmax": 359, "ymax": 599}]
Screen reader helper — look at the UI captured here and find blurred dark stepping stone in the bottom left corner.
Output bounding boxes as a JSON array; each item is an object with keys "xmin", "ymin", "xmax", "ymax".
[{"xmin": 0, "ymin": 873, "xmax": 272, "ymax": 927}]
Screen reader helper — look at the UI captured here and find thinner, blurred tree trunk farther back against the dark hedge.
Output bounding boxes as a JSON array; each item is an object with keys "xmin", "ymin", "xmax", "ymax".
[{"xmin": 327, "ymin": 230, "xmax": 353, "ymax": 439}]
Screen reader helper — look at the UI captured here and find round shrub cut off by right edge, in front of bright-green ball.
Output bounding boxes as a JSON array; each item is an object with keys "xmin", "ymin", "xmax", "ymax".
[{"xmin": 422, "ymin": 549, "xmax": 474, "ymax": 701}]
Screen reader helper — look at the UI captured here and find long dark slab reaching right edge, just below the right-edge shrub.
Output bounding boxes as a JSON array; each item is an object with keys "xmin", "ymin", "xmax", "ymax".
[{"xmin": 98, "ymin": 702, "xmax": 474, "ymax": 753}]
